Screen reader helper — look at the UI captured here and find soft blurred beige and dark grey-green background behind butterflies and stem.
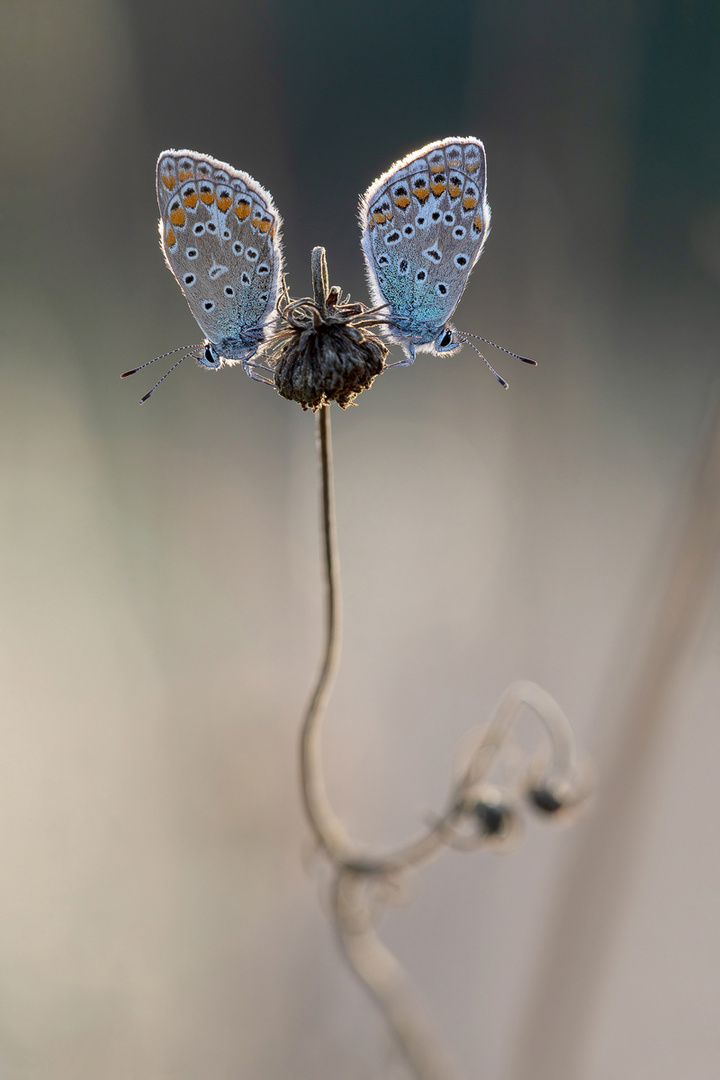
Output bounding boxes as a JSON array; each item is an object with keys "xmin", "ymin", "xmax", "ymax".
[{"xmin": 0, "ymin": 0, "xmax": 720, "ymax": 1080}]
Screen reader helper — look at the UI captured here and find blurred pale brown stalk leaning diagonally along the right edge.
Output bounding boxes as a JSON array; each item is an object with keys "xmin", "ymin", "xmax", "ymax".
[{"xmin": 511, "ymin": 395, "xmax": 720, "ymax": 1080}]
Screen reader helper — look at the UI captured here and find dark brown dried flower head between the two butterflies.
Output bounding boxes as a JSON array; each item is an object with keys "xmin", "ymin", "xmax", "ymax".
[{"xmin": 266, "ymin": 247, "xmax": 388, "ymax": 411}]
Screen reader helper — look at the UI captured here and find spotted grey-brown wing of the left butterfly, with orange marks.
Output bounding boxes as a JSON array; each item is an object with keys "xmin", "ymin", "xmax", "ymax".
[{"xmin": 157, "ymin": 150, "xmax": 283, "ymax": 364}]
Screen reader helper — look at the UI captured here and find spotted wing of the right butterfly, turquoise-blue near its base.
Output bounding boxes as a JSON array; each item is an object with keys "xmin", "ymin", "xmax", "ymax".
[{"xmin": 361, "ymin": 138, "xmax": 490, "ymax": 354}]
